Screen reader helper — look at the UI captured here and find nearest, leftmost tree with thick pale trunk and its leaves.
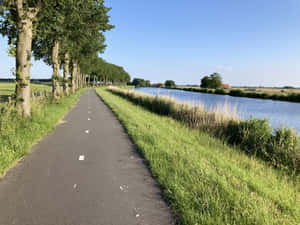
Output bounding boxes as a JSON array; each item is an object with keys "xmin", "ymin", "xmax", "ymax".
[{"xmin": 0, "ymin": 0, "xmax": 43, "ymax": 116}]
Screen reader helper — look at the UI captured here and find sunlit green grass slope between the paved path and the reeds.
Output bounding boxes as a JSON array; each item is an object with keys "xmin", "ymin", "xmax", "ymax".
[{"xmin": 97, "ymin": 89, "xmax": 300, "ymax": 225}]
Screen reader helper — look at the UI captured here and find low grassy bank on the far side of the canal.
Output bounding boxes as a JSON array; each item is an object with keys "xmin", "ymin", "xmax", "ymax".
[{"xmin": 172, "ymin": 87, "xmax": 300, "ymax": 102}]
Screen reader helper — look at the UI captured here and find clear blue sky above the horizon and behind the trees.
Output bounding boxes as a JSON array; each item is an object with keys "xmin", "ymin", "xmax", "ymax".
[{"xmin": 0, "ymin": 0, "xmax": 300, "ymax": 87}]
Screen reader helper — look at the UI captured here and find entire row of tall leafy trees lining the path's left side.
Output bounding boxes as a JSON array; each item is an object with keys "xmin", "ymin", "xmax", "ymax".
[{"xmin": 0, "ymin": 0, "xmax": 130, "ymax": 116}]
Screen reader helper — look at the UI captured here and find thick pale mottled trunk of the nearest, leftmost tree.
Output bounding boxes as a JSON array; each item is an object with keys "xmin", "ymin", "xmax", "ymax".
[{"xmin": 13, "ymin": 0, "xmax": 40, "ymax": 117}]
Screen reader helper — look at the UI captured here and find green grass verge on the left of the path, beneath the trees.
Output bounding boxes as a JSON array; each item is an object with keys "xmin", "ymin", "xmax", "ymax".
[{"xmin": 0, "ymin": 90, "xmax": 82, "ymax": 177}]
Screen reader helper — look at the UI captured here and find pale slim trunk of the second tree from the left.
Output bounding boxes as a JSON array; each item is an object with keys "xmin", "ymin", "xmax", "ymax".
[{"xmin": 52, "ymin": 40, "xmax": 60, "ymax": 100}]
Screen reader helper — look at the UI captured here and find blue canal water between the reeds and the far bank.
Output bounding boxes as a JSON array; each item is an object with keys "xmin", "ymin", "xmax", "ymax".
[{"xmin": 134, "ymin": 88, "xmax": 300, "ymax": 133}]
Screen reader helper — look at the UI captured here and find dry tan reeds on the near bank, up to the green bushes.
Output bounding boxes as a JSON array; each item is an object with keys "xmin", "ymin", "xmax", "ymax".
[{"xmin": 109, "ymin": 87, "xmax": 239, "ymax": 133}]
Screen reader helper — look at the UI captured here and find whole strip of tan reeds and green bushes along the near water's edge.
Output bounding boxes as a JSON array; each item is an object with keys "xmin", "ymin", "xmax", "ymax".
[{"xmin": 109, "ymin": 87, "xmax": 300, "ymax": 174}]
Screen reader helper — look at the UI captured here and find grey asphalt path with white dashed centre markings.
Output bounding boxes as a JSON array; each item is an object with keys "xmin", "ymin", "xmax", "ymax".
[{"xmin": 0, "ymin": 90, "xmax": 174, "ymax": 225}]
